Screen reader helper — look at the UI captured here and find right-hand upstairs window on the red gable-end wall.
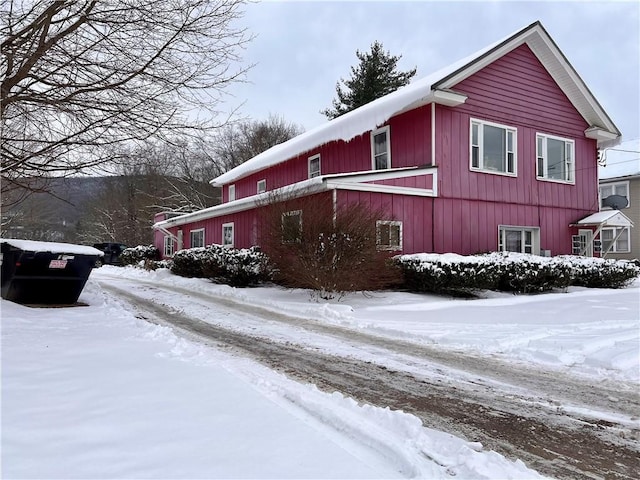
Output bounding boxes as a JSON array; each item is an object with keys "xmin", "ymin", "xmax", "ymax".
[{"xmin": 536, "ymin": 133, "xmax": 575, "ymax": 183}]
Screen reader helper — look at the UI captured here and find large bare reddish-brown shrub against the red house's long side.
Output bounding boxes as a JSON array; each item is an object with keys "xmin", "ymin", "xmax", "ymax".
[{"xmin": 259, "ymin": 189, "xmax": 400, "ymax": 299}]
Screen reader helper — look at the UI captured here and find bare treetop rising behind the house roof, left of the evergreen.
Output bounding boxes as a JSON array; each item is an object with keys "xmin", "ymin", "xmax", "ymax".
[{"xmin": 212, "ymin": 115, "xmax": 304, "ymax": 172}]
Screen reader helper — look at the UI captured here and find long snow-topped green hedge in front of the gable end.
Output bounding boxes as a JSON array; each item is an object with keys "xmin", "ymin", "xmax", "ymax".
[{"xmin": 396, "ymin": 253, "xmax": 640, "ymax": 295}]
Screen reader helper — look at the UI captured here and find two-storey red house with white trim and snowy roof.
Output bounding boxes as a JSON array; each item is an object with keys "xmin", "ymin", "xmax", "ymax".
[{"xmin": 154, "ymin": 22, "xmax": 621, "ymax": 256}]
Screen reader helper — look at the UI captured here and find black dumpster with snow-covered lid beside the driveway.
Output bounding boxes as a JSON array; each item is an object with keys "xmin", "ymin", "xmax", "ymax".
[{"xmin": 0, "ymin": 238, "xmax": 103, "ymax": 305}]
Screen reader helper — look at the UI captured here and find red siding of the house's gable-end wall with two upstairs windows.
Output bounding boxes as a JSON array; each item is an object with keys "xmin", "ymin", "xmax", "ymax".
[{"xmin": 435, "ymin": 45, "xmax": 598, "ymax": 253}]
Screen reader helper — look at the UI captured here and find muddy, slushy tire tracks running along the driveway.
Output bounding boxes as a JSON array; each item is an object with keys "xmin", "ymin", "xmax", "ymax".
[{"xmin": 102, "ymin": 278, "xmax": 640, "ymax": 478}]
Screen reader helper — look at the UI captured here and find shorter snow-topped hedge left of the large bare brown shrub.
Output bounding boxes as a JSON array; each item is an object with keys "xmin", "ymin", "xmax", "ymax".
[{"xmin": 171, "ymin": 244, "xmax": 271, "ymax": 287}]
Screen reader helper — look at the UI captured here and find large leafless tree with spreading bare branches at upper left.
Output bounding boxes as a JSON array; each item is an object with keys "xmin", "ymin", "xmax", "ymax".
[{"xmin": 0, "ymin": 0, "xmax": 249, "ymax": 199}]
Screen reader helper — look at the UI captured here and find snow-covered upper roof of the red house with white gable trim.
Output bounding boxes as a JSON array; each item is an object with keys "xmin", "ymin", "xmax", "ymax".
[{"xmin": 211, "ymin": 22, "xmax": 620, "ymax": 186}]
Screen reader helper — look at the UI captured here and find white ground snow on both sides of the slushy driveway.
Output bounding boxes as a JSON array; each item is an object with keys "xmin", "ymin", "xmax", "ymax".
[{"xmin": 6, "ymin": 267, "xmax": 640, "ymax": 478}]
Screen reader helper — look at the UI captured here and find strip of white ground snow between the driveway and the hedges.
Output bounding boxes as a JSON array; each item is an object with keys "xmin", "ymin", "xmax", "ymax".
[{"xmin": 99, "ymin": 267, "xmax": 640, "ymax": 383}]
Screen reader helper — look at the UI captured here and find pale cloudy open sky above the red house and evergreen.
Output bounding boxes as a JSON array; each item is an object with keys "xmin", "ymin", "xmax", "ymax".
[{"xmin": 225, "ymin": 1, "xmax": 640, "ymax": 140}]
